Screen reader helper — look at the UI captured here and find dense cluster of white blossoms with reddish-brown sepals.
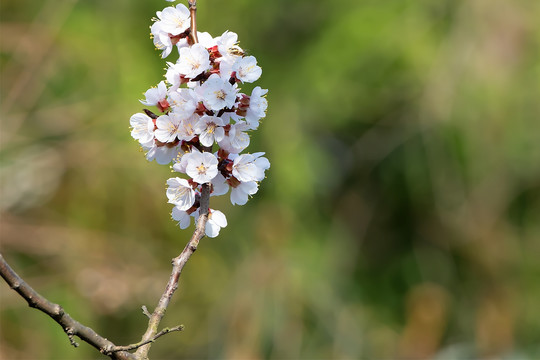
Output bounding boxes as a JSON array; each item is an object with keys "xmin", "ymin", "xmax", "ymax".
[{"xmin": 130, "ymin": 4, "xmax": 270, "ymax": 237}]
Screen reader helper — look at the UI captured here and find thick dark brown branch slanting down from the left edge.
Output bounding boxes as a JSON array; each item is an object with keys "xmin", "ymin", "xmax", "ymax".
[{"xmin": 0, "ymin": 254, "xmax": 136, "ymax": 360}]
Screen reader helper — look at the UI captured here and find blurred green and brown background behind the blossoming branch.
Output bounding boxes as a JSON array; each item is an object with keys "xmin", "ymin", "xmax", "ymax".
[{"xmin": 0, "ymin": 0, "xmax": 540, "ymax": 360}]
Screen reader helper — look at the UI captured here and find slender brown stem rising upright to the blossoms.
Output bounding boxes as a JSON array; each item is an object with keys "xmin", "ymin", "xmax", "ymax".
[{"xmin": 136, "ymin": 184, "xmax": 210, "ymax": 359}]
